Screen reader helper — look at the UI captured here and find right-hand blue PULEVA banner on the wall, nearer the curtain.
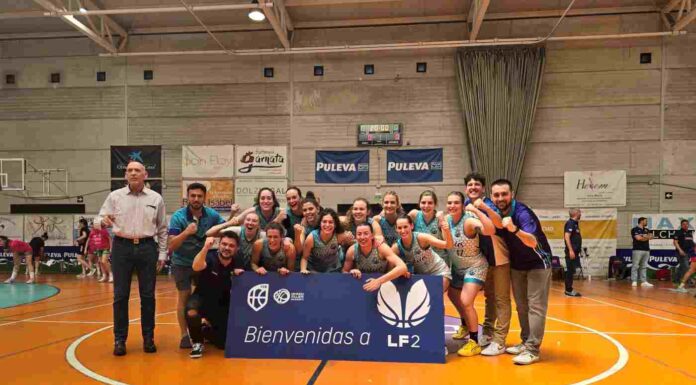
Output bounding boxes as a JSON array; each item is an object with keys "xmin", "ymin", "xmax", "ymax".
[{"xmin": 387, "ymin": 148, "xmax": 442, "ymax": 183}]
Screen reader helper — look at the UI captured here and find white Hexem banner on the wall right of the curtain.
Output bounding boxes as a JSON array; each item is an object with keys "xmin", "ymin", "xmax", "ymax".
[{"xmin": 563, "ymin": 170, "xmax": 626, "ymax": 207}]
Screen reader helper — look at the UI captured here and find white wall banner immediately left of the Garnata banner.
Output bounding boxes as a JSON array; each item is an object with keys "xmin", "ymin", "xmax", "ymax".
[{"xmin": 181, "ymin": 145, "xmax": 234, "ymax": 178}]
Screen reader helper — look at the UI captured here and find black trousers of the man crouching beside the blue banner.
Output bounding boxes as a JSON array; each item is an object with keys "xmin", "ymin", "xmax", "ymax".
[{"xmin": 185, "ymin": 292, "xmax": 229, "ymax": 349}]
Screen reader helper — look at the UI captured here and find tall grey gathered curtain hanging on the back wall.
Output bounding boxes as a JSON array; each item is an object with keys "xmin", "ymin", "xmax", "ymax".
[{"xmin": 456, "ymin": 46, "xmax": 545, "ymax": 190}]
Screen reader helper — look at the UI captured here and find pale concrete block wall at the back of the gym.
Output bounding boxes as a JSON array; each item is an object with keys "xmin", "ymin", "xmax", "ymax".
[{"xmin": 0, "ymin": 14, "xmax": 696, "ymax": 250}]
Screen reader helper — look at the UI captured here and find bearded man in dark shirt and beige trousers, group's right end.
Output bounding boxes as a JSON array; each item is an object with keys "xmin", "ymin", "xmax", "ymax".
[{"xmin": 491, "ymin": 179, "xmax": 551, "ymax": 365}]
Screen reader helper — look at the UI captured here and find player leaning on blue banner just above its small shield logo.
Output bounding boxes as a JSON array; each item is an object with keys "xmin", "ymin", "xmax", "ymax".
[{"xmin": 251, "ymin": 223, "xmax": 295, "ymax": 275}]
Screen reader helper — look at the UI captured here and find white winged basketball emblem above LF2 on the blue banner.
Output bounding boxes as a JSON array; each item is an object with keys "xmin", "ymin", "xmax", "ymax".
[{"xmin": 377, "ymin": 279, "xmax": 430, "ymax": 329}]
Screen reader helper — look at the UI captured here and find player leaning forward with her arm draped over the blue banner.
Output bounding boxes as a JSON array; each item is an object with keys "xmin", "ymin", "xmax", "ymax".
[{"xmin": 343, "ymin": 223, "xmax": 407, "ymax": 291}]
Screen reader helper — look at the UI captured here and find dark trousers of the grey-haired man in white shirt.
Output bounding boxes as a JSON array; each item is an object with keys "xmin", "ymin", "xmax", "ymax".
[{"xmin": 111, "ymin": 238, "xmax": 157, "ymax": 342}]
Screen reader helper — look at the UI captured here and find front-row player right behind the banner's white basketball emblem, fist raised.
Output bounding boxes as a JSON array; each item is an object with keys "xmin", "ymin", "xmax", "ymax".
[{"xmin": 392, "ymin": 215, "xmax": 454, "ymax": 292}]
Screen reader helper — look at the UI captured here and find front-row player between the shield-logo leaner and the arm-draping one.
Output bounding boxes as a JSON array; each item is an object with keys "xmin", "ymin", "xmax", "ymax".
[{"xmin": 300, "ymin": 209, "xmax": 354, "ymax": 274}]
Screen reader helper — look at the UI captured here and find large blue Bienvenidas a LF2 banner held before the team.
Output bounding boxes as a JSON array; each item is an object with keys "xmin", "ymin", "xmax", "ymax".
[{"xmin": 225, "ymin": 273, "xmax": 445, "ymax": 363}]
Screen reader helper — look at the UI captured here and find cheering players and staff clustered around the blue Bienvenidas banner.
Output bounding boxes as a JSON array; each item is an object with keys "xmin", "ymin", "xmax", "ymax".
[{"xmin": 168, "ymin": 173, "xmax": 551, "ymax": 365}]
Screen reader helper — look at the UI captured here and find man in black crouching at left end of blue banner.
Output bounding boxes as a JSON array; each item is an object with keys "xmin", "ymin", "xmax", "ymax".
[{"xmin": 186, "ymin": 231, "xmax": 244, "ymax": 358}]
